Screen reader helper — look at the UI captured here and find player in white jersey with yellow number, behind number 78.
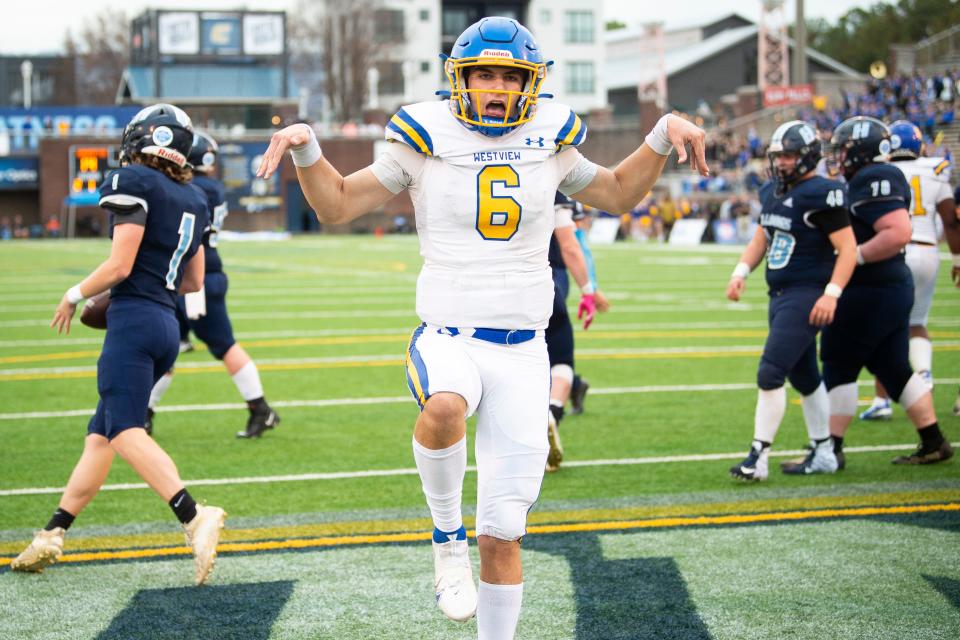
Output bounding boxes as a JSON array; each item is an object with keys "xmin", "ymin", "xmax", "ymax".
[{"xmin": 860, "ymin": 120, "xmax": 960, "ymax": 420}]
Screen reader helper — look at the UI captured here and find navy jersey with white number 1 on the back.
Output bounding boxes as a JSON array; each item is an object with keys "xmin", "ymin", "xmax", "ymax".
[{"xmin": 100, "ymin": 164, "xmax": 208, "ymax": 308}]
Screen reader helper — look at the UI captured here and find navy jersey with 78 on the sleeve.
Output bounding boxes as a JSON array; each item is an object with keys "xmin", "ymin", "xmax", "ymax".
[{"xmin": 847, "ymin": 163, "xmax": 911, "ymax": 285}]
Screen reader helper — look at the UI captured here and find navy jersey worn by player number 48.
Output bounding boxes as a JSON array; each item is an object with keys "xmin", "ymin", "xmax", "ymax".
[{"xmin": 760, "ymin": 176, "xmax": 844, "ymax": 289}]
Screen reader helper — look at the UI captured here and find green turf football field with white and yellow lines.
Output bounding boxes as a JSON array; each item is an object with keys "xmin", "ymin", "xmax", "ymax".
[{"xmin": 0, "ymin": 237, "xmax": 960, "ymax": 640}]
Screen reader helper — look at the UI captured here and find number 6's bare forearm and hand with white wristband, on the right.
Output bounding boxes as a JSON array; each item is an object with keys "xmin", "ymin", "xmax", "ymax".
[{"xmin": 572, "ymin": 114, "xmax": 710, "ymax": 213}]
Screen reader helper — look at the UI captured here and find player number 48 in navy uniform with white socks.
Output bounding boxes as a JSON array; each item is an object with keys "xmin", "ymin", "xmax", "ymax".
[{"xmin": 727, "ymin": 120, "xmax": 857, "ymax": 481}]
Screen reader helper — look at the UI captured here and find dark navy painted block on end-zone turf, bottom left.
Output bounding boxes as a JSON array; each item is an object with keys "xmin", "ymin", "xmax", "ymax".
[{"xmin": 96, "ymin": 580, "xmax": 294, "ymax": 640}]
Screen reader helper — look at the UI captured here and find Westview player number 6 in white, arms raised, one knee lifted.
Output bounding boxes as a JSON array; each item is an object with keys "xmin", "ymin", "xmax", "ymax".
[{"xmin": 258, "ymin": 17, "xmax": 708, "ymax": 640}]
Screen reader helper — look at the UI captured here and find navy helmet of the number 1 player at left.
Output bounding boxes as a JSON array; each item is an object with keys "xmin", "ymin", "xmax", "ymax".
[{"xmin": 120, "ymin": 103, "xmax": 193, "ymax": 168}]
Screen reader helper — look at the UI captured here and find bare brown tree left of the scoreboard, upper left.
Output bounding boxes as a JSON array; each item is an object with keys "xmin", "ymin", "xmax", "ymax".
[{"xmin": 64, "ymin": 9, "xmax": 130, "ymax": 104}]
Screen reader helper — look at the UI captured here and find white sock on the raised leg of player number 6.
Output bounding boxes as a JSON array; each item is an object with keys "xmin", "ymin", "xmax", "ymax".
[{"xmin": 413, "ymin": 436, "xmax": 467, "ymax": 533}]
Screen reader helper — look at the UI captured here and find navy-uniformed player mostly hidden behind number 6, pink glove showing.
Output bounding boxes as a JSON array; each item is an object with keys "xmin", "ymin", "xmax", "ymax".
[{"xmin": 545, "ymin": 191, "xmax": 610, "ymax": 471}]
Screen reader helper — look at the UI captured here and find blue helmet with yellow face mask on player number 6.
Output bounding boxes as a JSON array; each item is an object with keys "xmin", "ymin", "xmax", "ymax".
[{"xmin": 444, "ymin": 16, "xmax": 547, "ymax": 137}]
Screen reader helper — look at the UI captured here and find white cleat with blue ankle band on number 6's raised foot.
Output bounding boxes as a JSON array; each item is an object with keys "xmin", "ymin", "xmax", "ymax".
[{"xmin": 433, "ymin": 527, "xmax": 477, "ymax": 622}]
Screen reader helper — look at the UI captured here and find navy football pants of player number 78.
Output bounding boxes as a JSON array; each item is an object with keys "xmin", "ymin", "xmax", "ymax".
[{"xmin": 820, "ymin": 281, "xmax": 913, "ymax": 401}]
